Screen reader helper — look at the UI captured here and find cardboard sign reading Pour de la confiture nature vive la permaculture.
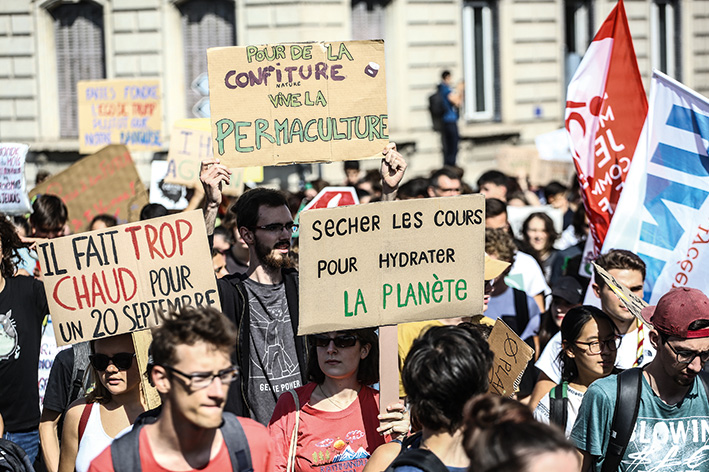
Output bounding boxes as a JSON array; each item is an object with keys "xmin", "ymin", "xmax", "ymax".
[{"xmin": 207, "ymin": 41, "xmax": 389, "ymax": 167}]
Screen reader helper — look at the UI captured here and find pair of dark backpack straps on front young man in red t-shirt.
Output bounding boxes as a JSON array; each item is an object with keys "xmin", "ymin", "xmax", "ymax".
[{"xmin": 111, "ymin": 407, "xmax": 254, "ymax": 472}]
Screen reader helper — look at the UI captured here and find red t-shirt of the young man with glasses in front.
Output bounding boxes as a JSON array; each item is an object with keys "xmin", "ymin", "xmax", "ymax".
[{"xmin": 88, "ymin": 417, "xmax": 274, "ymax": 472}]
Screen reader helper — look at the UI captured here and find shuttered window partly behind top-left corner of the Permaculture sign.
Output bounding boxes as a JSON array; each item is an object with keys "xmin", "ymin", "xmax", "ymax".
[{"xmin": 179, "ymin": 0, "xmax": 236, "ymax": 118}]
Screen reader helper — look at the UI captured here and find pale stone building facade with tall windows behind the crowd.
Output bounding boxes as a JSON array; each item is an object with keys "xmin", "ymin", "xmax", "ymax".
[{"xmin": 0, "ymin": 0, "xmax": 709, "ymax": 187}]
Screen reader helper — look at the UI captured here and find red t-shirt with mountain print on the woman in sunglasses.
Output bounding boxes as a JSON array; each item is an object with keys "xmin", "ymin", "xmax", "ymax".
[{"xmin": 268, "ymin": 383, "xmax": 385, "ymax": 472}]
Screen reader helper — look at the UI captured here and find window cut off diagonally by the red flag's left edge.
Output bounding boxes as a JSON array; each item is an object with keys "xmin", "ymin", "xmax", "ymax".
[{"xmin": 564, "ymin": 0, "xmax": 593, "ymax": 88}]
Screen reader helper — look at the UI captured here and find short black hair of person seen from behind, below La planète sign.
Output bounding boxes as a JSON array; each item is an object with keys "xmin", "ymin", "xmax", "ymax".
[{"xmin": 401, "ymin": 323, "xmax": 493, "ymax": 433}]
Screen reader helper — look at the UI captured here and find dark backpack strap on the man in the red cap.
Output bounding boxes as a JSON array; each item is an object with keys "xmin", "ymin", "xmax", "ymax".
[{"xmin": 601, "ymin": 368, "xmax": 643, "ymax": 472}]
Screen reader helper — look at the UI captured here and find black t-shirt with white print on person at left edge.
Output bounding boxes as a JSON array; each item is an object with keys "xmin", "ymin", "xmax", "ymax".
[{"xmin": 0, "ymin": 275, "xmax": 49, "ymax": 432}]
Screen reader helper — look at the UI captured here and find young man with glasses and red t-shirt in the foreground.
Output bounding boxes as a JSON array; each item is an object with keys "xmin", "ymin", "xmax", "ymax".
[{"xmin": 89, "ymin": 307, "xmax": 274, "ymax": 472}]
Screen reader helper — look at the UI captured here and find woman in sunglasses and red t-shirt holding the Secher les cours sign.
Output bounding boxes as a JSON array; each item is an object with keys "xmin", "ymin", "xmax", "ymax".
[{"xmin": 268, "ymin": 328, "xmax": 408, "ymax": 472}]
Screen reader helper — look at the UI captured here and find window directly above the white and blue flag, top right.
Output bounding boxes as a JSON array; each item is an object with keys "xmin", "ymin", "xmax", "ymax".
[{"xmin": 650, "ymin": 0, "xmax": 682, "ymax": 80}]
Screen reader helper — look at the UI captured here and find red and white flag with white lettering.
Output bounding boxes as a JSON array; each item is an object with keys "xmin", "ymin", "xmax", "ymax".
[{"xmin": 566, "ymin": 0, "xmax": 647, "ymax": 254}]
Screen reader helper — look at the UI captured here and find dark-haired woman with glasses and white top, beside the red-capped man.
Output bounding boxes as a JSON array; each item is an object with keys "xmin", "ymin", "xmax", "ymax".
[{"xmin": 534, "ymin": 305, "xmax": 620, "ymax": 437}]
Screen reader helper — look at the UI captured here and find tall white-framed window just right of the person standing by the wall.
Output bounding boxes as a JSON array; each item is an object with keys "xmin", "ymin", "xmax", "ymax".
[{"xmin": 463, "ymin": 1, "xmax": 500, "ymax": 120}]
